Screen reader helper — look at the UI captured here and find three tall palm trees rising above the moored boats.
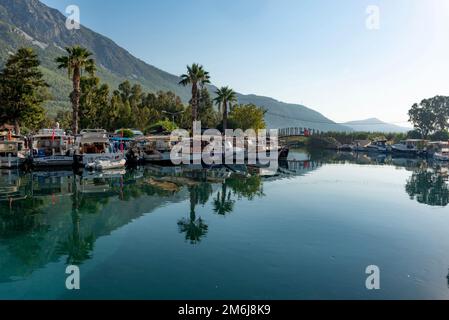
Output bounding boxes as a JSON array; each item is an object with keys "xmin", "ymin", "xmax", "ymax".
[{"xmin": 56, "ymin": 46, "xmax": 237, "ymax": 134}]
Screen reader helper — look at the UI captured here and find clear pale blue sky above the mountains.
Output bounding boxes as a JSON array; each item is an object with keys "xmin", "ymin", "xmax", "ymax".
[{"xmin": 43, "ymin": 0, "xmax": 449, "ymax": 122}]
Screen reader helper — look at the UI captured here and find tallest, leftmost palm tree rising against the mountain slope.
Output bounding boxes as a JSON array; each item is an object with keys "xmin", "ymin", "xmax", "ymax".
[{"xmin": 56, "ymin": 46, "xmax": 95, "ymax": 134}]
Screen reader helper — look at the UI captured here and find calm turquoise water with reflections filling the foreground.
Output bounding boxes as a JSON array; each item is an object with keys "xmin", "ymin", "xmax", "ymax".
[{"xmin": 0, "ymin": 151, "xmax": 449, "ymax": 299}]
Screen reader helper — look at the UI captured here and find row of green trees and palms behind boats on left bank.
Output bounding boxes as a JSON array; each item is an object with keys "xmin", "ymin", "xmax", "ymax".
[{"xmin": 0, "ymin": 46, "xmax": 265, "ymax": 134}]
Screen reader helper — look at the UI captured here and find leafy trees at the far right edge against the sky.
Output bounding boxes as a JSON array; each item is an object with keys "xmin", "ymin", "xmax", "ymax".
[{"xmin": 408, "ymin": 96, "xmax": 449, "ymax": 140}]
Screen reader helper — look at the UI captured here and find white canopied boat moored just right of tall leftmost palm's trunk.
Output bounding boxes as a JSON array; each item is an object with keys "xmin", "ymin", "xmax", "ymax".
[{"xmin": 75, "ymin": 129, "xmax": 125, "ymax": 167}]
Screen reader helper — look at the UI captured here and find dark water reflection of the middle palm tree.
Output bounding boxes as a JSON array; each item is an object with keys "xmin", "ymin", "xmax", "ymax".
[{"xmin": 178, "ymin": 183, "xmax": 211, "ymax": 244}]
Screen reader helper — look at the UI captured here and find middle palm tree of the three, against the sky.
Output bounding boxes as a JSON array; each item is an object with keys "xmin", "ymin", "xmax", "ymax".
[{"xmin": 179, "ymin": 63, "xmax": 210, "ymax": 121}]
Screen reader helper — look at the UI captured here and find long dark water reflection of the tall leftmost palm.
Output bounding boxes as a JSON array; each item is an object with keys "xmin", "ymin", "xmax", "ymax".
[{"xmin": 58, "ymin": 176, "xmax": 94, "ymax": 265}]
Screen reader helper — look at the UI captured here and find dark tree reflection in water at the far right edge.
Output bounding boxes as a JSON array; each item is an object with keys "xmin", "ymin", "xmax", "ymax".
[{"xmin": 405, "ymin": 167, "xmax": 449, "ymax": 207}]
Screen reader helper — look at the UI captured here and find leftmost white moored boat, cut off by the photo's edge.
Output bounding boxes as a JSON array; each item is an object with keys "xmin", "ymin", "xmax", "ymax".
[{"xmin": 0, "ymin": 137, "xmax": 28, "ymax": 169}]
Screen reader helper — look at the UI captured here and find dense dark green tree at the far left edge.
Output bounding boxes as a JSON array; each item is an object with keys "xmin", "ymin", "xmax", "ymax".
[{"xmin": 0, "ymin": 48, "xmax": 48, "ymax": 134}]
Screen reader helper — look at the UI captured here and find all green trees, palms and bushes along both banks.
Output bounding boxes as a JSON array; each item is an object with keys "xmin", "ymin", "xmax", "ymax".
[{"xmin": 0, "ymin": 46, "xmax": 449, "ymax": 140}]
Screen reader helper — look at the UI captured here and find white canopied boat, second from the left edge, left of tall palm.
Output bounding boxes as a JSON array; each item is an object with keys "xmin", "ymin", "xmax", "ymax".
[{"xmin": 32, "ymin": 129, "xmax": 74, "ymax": 167}]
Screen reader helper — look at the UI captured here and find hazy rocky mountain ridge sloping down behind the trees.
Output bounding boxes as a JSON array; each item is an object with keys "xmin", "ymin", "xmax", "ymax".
[{"xmin": 0, "ymin": 0, "xmax": 364, "ymax": 131}]
